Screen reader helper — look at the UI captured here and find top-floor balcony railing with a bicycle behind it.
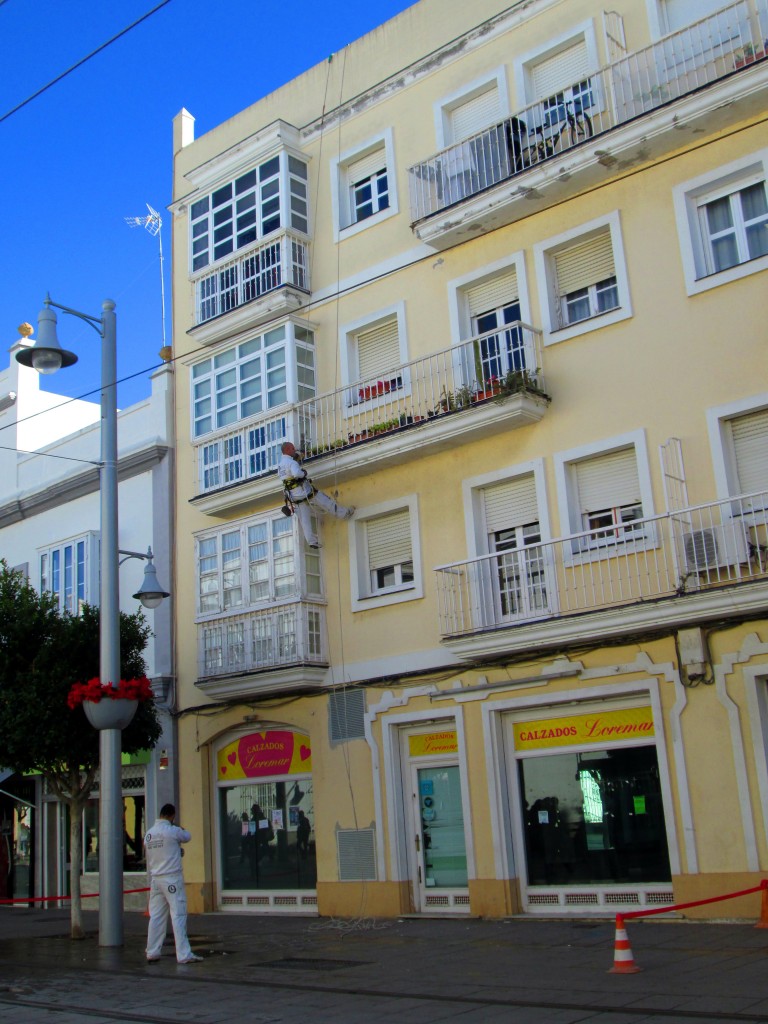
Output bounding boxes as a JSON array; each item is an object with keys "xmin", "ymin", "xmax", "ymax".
[{"xmin": 408, "ymin": 0, "xmax": 768, "ymax": 221}]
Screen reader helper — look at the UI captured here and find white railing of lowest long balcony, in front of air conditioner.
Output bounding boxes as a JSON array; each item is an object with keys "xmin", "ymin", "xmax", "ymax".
[{"xmin": 435, "ymin": 492, "xmax": 768, "ymax": 638}]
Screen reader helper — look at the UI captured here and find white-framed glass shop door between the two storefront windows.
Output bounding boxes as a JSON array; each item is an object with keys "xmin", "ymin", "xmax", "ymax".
[{"xmin": 413, "ymin": 765, "xmax": 469, "ymax": 912}]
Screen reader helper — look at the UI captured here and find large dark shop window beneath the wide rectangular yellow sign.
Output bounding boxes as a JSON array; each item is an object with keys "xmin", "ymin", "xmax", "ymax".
[{"xmin": 518, "ymin": 744, "xmax": 671, "ymax": 886}]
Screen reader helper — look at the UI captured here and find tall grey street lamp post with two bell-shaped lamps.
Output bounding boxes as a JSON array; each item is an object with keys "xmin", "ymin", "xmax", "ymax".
[{"xmin": 16, "ymin": 296, "xmax": 167, "ymax": 946}]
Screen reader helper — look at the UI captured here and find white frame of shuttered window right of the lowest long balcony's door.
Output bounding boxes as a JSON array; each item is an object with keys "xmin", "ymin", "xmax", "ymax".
[{"xmin": 553, "ymin": 429, "xmax": 658, "ymax": 564}]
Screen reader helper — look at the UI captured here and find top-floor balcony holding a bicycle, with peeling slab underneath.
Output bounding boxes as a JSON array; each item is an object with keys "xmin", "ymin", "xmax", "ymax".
[{"xmin": 408, "ymin": 0, "xmax": 768, "ymax": 249}]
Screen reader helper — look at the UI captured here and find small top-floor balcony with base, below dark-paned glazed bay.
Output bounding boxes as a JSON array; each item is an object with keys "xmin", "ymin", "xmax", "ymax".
[{"xmin": 193, "ymin": 231, "xmax": 309, "ymax": 344}]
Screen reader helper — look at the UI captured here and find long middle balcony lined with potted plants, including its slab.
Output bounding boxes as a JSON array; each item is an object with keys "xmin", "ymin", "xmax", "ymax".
[{"xmin": 193, "ymin": 322, "xmax": 550, "ymax": 514}]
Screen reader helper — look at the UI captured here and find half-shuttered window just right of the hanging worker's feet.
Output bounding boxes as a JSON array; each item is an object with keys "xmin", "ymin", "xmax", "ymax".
[{"xmin": 350, "ymin": 497, "xmax": 423, "ymax": 611}]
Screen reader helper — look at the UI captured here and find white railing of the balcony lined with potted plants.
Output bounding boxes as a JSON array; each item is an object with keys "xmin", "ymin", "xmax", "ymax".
[{"xmin": 198, "ymin": 322, "xmax": 549, "ymax": 494}]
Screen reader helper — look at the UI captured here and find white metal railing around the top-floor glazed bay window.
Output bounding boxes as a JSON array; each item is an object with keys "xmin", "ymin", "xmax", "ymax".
[{"xmin": 194, "ymin": 231, "xmax": 309, "ymax": 324}]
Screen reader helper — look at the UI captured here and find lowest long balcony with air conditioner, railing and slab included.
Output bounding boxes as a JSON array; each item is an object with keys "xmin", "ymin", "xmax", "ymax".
[{"xmin": 435, "ymin": 492, "xmax": 768, "ymax": 659}]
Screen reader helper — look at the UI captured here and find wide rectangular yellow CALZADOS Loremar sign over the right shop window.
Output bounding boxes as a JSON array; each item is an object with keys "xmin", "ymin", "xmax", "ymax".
[{"xmin": 515, "ymin": 708, "xmax": 653, "ymax": 751}]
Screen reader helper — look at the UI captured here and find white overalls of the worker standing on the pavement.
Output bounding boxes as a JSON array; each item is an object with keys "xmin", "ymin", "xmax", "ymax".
[{"xmin": 144, "ymin": 818, "xmax": 193, "ymax": 964}]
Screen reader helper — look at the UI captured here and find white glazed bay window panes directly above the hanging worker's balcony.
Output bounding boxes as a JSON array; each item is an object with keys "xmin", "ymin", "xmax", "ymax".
[{"xmin": 191, "ymin": 324, "xmax": 315, "ymax": 438}]
